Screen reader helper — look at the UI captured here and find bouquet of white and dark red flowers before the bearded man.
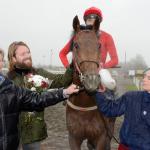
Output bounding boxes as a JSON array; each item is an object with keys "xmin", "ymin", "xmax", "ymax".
[{"xmin": 24, "ymin": 74, "xmax": 50, "ymax": 124}]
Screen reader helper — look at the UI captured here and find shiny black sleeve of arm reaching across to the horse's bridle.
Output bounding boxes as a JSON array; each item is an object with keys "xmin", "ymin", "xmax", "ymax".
[{"xmin": 14, "ymin": 85, "xmax": 65, "ymax": 111}]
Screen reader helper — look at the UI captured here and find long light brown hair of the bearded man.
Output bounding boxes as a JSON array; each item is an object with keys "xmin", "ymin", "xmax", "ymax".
[{"xmin": 8, "ymin": 41, "xmax": 30, "ymax": 71}]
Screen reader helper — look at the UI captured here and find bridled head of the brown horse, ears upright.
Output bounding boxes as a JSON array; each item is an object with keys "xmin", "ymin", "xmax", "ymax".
[{"xmin": 73, "ymin": 16, "xmax": 100, "ymax": 92}]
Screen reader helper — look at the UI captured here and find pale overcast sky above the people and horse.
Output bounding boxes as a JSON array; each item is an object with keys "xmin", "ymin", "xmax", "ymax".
[{"xmin": 0, "ymin": 0, "xmax": 150, "ymax": 66}]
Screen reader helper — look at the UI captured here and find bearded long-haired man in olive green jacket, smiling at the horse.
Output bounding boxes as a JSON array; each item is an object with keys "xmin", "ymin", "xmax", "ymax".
[{"xmin": 8, "ymin": 41, "xmax": 71, "ymax": 150}]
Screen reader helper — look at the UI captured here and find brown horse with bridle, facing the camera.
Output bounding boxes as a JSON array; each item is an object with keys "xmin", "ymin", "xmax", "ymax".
[{"xmin": 66, "ymin": 16, "xmax": 115, "ymax": 150}]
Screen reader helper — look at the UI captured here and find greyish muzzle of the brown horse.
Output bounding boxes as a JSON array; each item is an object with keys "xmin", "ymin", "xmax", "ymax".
[{"xmin": 81, "ymin": 74, "xmax": 100, "ymax": 93}]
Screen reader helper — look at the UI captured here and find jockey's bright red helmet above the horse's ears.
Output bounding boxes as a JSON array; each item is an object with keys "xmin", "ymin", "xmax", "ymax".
[{"xmin": 83, "ymin": 7, "xmax": 103, "ymax": 20}]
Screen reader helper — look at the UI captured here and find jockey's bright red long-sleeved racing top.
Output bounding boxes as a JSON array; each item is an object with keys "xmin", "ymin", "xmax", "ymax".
[{"xmin": 59, "ymin": 31, "xmax": 118, "ymax": 68}]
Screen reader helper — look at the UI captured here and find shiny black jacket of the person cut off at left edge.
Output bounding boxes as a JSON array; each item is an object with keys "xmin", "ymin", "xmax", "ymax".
[{"xmin": 0, "ymin": 74, "xmax": 64, "ymax": 150}]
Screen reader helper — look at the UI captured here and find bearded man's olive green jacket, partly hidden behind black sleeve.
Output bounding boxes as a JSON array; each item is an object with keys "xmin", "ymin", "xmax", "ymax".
[{"xmin": 7, "ymin": 67, "xmax": 70, "ymax": 145}]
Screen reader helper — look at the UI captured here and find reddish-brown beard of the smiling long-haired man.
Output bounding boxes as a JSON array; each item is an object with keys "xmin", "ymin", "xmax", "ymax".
[{"xmin": 15, "ymin": 58, "xmax": 32, "ymax": 69}]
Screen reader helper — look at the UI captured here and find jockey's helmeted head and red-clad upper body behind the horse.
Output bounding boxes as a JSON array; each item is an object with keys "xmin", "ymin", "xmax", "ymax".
[{"xmin": 59, "ymin": 7, "xmax": 118, "ymax": 89}]
